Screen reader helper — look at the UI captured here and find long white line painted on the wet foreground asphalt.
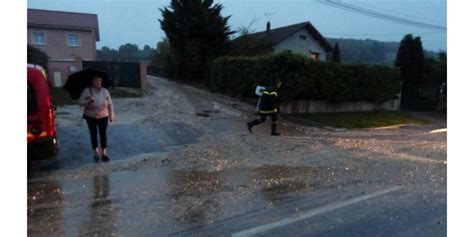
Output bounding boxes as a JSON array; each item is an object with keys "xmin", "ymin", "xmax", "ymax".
[{"xmin": 232, "ymin": 186, "xmax": 402, "ymax": 237}]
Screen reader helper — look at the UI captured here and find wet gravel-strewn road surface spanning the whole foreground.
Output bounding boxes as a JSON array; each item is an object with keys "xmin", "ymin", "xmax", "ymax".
[{"xmin": 27, "ymin": 77, "xmax": 447, "ymax": 236}]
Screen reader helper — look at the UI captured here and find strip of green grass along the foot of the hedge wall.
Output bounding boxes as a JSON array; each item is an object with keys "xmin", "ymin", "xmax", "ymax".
[{"xmin": 284, "ymin": 110, "xmax": 430, "ymax": 129}]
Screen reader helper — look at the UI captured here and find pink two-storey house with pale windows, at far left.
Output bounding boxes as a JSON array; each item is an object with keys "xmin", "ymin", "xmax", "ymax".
[{"xmin": 27, "ymin": 9, "xmax": 100, "ymax": 87}]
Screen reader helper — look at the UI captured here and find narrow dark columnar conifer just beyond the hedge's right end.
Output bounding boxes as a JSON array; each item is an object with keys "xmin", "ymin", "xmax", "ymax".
[{"xmin": 395, "ymin": 34, "xmax": 424, "ymax": 109}]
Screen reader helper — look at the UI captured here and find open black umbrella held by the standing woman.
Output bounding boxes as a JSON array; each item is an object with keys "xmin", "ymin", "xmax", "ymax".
[{"xmin": 63, "ymin": 68, "xmax": 113, "ymax": 99}]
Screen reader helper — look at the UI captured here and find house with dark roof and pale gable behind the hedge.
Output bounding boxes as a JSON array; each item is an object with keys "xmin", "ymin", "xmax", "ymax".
[{"xmin": 232, "ymin": 21, "xmax": 332, "ymax": 61}]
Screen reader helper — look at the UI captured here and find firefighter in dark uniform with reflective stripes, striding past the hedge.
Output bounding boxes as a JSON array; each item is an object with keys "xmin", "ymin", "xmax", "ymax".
[{"xmin": 247, "ymin": 80, "xmax": 281, "ymax": 136}]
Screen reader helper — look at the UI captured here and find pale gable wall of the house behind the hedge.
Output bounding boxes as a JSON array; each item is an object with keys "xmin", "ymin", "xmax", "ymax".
[{"xmin": 274, "ymin": 29, "xmax": 327, "ymax": 61}]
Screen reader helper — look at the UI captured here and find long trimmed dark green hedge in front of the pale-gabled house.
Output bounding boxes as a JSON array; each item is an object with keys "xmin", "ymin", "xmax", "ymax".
[{"xmin": 210, "ymin": 53, "xmax": 399, "ymax": 102}]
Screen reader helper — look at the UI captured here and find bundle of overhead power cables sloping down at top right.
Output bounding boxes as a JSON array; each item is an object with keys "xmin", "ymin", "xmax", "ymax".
[{"xmin": 316, "ymin": 0, "xmax": 447, "ymax": 31}]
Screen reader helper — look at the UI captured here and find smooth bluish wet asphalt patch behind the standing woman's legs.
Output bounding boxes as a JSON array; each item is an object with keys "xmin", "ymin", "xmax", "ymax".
[{"xmin": 35, "ymin": 123, "xmax": 202, "ymax": 171}]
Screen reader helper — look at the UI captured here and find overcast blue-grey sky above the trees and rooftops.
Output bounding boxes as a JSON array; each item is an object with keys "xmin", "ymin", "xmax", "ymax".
[{"xmin": 27, "ymin": 0, "xmax": 447, "ymax": 51}]
